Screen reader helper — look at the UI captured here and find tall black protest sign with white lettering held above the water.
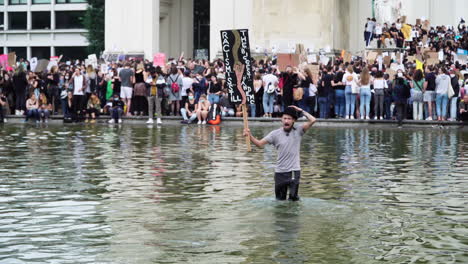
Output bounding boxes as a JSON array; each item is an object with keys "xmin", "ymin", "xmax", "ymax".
[{"xmin": 221, "ymin": 29, "xmax": 255, "ymax": 104}]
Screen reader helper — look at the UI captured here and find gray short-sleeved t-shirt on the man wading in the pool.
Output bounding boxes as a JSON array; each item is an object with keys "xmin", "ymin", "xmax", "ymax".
[{"xmin": 265, "ymin": 125, "xmax": 304, "ymax": 173}]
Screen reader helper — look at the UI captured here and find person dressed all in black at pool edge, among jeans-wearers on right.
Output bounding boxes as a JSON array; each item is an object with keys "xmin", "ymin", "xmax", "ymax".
[{"xmin": 393, "ymin": 70, "xmax": 410, "ymax": 127}]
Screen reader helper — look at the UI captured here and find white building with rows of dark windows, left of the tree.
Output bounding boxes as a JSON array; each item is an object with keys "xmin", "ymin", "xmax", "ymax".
[{"xmin": 0, "ymin": 0, "xmax": 88, "ymax": 59}]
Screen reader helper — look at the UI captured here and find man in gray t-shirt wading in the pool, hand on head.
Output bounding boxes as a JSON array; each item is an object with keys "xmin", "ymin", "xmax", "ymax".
[{"xmin": 244, "ymin": 106, "xmax": 315, "ymax": 201}]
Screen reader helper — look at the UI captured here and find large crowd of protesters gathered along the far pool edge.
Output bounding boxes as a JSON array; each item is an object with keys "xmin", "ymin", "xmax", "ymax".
[{"xmin": 0, "ymin": 19, "xmax": 468, "ymax": 125}]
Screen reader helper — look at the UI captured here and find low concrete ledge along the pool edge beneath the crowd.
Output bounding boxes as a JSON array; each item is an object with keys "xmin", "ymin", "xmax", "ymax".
[{"xmin": 6, "ymin": 115, "xmax": 468, "ymax": 131}]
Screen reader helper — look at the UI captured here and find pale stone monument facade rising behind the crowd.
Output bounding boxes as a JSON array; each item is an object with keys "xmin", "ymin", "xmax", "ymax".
[{"xmin": 106, "ymin": 0, "xmax": 468, "ymax": 58}]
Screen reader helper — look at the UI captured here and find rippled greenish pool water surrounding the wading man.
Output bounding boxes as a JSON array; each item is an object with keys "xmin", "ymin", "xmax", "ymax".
[{"xmin": 0, "ymin": 125, "xmax": 468, "ymax": 264}]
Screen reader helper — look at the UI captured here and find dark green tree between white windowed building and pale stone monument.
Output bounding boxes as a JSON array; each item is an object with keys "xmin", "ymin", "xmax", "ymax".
[{"xmin": 83, "ymin": 0, "xmax": 105, "ymax": 56}]
